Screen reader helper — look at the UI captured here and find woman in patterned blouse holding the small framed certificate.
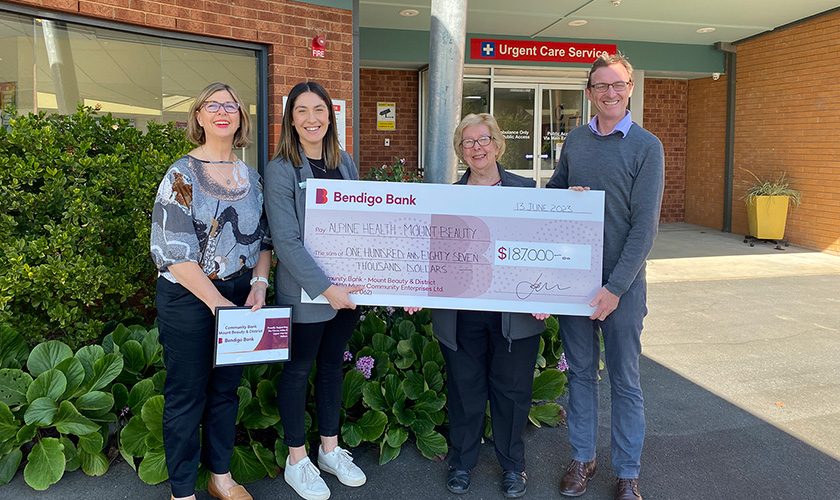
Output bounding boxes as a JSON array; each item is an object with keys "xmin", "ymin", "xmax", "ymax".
[{"xmin": 151, "ymin": 83, "xmax": 272, "ymax": 500}]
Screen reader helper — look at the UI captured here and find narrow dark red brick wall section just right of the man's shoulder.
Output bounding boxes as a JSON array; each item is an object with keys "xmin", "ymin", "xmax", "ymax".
[{"xmin": 644, "ymin": 78, "xmax": 688, "ymax": 222}]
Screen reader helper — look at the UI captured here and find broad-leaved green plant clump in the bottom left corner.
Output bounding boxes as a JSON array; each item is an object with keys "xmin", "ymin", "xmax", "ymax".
[{"xmin": 0, "ymin": 328, "xmax": 123, "ymax": 490}]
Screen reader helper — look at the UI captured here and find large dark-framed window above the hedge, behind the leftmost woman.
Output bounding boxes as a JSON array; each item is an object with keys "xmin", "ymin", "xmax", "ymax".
[{"xmin": 0, "ymin": 7, "xmax": 267, "ymax": 167}]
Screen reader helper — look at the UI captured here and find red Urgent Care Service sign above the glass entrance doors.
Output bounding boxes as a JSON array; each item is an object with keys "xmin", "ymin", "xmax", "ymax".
[{"xmin": 470, "ymin": 38, "xmax": 616, "ymax": 64}]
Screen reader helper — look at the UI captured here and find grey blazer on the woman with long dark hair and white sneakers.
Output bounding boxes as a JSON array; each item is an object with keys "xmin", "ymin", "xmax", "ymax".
[{"xmin": 264, "ymin": 148, "xmax": 359, "ymax": 323}]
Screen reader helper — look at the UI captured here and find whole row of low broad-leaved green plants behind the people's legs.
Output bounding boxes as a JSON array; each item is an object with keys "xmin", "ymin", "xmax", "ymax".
[{"xmin": 0, "ymin": 307, "xmax": 566, "ymax": 490}]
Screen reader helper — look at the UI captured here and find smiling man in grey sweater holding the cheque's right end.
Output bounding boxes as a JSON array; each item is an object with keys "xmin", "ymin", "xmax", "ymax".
[{"xmin": 546, "ymin": 54, "xmax": 665, "ymax": 500}]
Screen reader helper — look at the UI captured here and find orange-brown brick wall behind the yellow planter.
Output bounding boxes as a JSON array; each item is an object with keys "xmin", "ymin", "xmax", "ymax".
[{"xmin": 732, "ymin": 12, "xmax": 840, "ymax": 254}]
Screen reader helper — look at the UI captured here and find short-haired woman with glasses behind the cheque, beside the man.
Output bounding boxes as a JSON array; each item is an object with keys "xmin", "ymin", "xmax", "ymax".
[{"xmin": 406, "ymin": 113, "xmax": 549, "ymax": 498}]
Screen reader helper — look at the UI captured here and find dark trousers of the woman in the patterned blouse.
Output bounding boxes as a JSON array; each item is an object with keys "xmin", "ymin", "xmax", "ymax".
[{"xmin": 156, "ymin": 273, "xmax": 251, "ymax": 497}]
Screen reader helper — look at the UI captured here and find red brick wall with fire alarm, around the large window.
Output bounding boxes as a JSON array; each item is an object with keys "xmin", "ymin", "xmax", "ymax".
[{"xmin": 14, "ymin": 0, "xmax": 353, "ymax": 152}]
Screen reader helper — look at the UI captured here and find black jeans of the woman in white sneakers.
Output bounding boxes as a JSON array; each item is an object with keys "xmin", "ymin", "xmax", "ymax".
[{"xmin": 277, "ymin": 309, "xmax": 359, "ymax": 447}]
